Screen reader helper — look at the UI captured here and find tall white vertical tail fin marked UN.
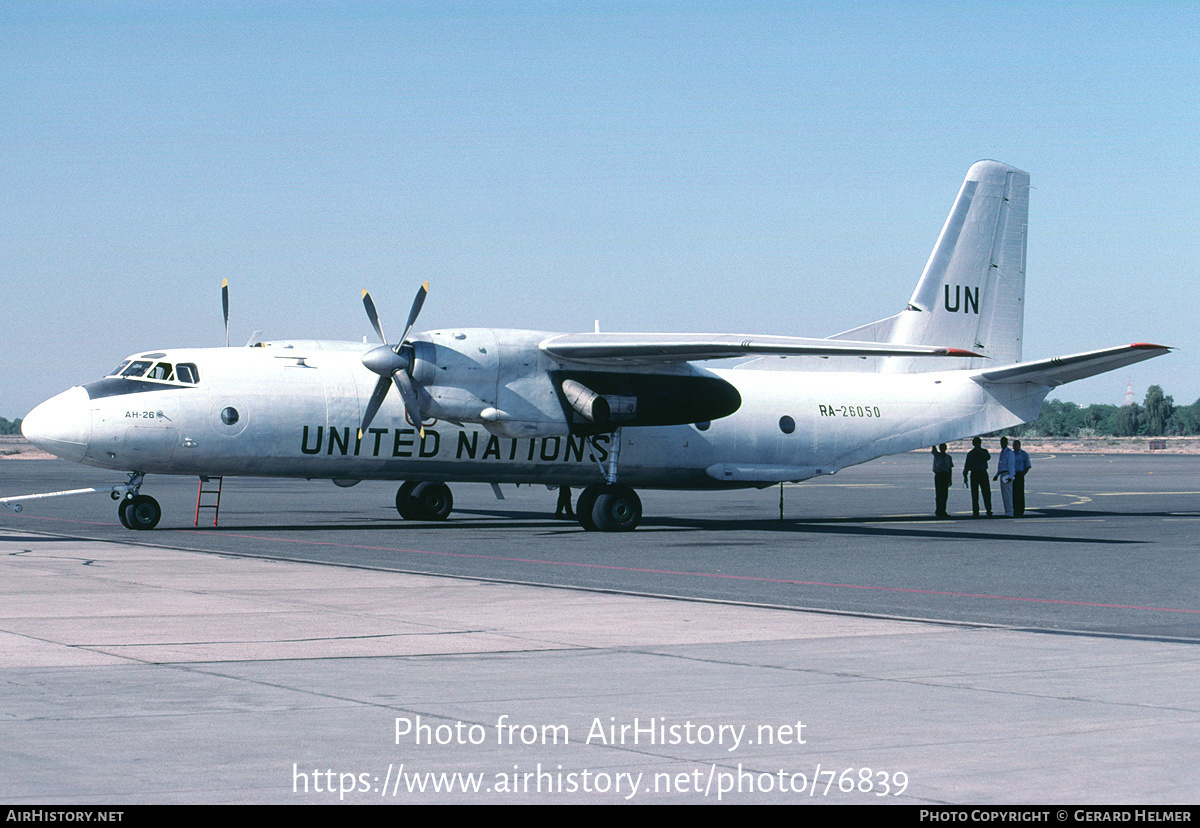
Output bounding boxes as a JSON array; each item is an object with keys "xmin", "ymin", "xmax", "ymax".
[{"xmin": 830, "ymin": 161, "xmax": 1030, "ymax": 372}]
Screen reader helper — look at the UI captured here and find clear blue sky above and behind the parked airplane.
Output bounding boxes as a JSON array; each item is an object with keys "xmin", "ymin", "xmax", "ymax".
[{"xmin": 0, "ymin": 0, "xmax": 1200, "ymax": 418}]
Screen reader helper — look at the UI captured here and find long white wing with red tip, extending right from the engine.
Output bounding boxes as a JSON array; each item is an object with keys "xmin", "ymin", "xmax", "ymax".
[{"xmin": 539, "ymin": 334, "xmax": 980, "ymax": 364}]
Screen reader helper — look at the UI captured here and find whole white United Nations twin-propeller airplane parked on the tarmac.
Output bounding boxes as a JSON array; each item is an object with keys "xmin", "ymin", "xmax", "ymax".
[{"xmin": 12, "ymin": 161, "xmax": 1170, "ymax": 532}]
